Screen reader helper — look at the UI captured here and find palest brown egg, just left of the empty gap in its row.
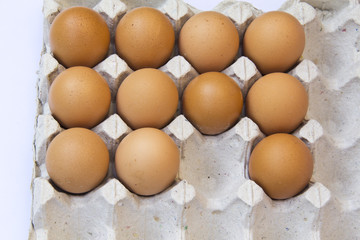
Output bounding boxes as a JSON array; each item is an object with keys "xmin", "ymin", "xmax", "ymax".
[{"xmin": 115, "ymin": 128, "xmax": 180, "ymax": 196}]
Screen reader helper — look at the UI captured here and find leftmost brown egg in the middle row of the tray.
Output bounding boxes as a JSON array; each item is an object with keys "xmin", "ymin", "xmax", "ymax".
[{"xmin": 49, "ymin": 67, "xmax": 111, "ymax": 128}]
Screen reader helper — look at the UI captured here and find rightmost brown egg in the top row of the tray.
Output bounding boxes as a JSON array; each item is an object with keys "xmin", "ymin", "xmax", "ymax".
[{"xmin": 243, "ymin": 11, "xmax": 305, "ymax": 75}]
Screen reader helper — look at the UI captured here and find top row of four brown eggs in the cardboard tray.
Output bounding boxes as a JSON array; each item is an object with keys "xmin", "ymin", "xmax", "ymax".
[{"xmin": 49, "ymin": 7, "xmax": 305, "ymax": 74}]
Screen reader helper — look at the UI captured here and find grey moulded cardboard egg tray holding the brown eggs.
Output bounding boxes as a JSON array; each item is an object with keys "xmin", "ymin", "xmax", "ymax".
[{"xmin": 29, "ymin": 0, "xmax": 360, "ymax": 240}]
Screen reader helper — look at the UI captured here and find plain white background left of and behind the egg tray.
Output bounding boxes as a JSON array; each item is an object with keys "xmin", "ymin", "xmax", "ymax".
[{"xmin": 0, "ymin": 0, "xmax": 284, "ymax": 240}]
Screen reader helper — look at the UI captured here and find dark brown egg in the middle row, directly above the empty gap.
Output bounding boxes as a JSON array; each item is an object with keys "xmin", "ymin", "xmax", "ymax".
[{"xmin": 182, "ymin": 72, "xmax": 243, "ymax": 135}]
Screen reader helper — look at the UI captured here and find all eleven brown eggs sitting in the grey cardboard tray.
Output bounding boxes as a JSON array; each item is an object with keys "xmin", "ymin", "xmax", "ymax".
[{"xmin": 46, "ymin": 7, "xmax": 313, "ymax": 199}]
